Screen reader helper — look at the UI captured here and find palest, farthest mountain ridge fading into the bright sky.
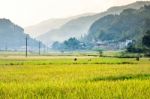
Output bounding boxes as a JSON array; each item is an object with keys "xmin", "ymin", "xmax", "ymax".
[{"xmin": 25, "ymin": 13, "xmax": 93, "ymax": 37}]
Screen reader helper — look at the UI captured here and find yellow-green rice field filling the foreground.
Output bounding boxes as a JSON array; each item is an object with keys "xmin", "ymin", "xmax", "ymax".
[{"xmin": 0, "ymin": 56, "xmax": 150, "ymax": 99}]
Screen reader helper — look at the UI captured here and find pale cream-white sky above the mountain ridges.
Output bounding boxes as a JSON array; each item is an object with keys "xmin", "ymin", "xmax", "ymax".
[{"xmin": 0, "ymin": 0, "xmax": 149, "ymax": 27}]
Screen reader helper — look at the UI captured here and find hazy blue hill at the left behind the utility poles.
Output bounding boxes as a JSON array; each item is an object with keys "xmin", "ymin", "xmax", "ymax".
[{"xmin": 0, "ymin": 19, "xmax": 41, "ymax": 50}]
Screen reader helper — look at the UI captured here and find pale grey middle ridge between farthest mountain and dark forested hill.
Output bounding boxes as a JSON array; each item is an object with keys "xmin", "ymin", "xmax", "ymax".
[{"xmin": 38, "ymin": 1, "xmax": 150, "ymax": 44}]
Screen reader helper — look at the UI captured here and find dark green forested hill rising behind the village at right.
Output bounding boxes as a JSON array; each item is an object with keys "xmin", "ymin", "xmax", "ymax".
[{"xmin": 86, "ymin": 6, "xmax": 150, "ymax": 42}]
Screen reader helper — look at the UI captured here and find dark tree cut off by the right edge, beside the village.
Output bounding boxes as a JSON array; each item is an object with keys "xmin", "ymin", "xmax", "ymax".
[{"xmin": 142, "ymin": 31, "xmax": 150, "ymax": 56}]
